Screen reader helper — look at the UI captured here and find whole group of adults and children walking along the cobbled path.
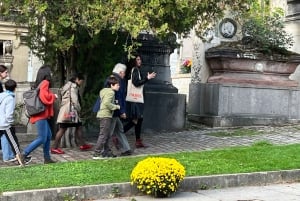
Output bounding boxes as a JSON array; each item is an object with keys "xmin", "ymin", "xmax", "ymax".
[{"xmin": 0, "ymin": 55, "xmax": 156, "ymax": 165}]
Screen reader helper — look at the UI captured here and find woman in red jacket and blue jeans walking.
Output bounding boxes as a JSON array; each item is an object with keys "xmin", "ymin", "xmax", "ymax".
[{"xmin": 22, "ymin": 65, "xmax": 57, "ymax": 164}]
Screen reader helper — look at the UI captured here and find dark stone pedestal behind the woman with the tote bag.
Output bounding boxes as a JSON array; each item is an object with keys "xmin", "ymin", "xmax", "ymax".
[{"xmin": 138, "ymin": 34, "xmax": 186, "ymax": 131}]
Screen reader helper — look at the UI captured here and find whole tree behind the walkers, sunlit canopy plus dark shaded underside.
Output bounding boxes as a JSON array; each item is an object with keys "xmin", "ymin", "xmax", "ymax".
[{"xmin": 0, "ymin": 0, "xmax": 255, "ymax": 129}]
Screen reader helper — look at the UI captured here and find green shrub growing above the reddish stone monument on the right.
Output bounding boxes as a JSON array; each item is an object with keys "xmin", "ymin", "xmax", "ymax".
[{"xmin": 242, "ymin": 1, "xmax": 294, "ymax": 55}]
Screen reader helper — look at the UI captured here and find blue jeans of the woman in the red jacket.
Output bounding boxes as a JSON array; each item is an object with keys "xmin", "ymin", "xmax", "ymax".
[{"xmin": 24, "ymin": 119, "xmax": 52, "ymax": 159}]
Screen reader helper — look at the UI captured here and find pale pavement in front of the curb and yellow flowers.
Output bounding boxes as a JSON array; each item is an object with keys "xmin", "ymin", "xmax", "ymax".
[{"xmin": 95, "ymin": 183, "xmax": 300, "ymax": 201}]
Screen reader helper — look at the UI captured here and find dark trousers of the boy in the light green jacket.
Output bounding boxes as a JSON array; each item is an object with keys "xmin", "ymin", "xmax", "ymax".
[{"xmin": 95, "ymin": 118, "xmax": 112, "ymax": 154}]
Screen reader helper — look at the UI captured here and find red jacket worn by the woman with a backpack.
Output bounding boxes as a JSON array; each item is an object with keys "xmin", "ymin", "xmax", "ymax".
[{"xmin": 30, "ymin": 80, "xmax": 56, "ymax": 124}]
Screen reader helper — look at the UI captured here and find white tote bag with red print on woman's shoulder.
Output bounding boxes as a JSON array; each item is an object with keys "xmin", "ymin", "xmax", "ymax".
[{"xmin": 126, "ymin": 69, "xmax": 144, "ymax": 103}]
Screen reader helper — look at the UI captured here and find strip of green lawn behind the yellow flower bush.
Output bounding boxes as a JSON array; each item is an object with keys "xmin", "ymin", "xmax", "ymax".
[{"xmin": 0, "ymin": 142, "xmax": 300, "ymax": 192}]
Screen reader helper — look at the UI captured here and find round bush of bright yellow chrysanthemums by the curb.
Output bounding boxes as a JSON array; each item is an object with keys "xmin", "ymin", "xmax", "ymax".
[{"xmin": 130, "ymin": 157, "xmax": 185, "ymax": 197}]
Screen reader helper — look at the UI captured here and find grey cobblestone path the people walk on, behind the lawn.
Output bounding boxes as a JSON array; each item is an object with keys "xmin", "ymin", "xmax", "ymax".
[{"xmin": 0, "ymin": 125, "xmax": 300, "ymax": 167}]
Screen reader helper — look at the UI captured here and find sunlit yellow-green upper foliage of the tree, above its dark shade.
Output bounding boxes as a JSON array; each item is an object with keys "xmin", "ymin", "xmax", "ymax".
[{"xmin": 1, "ymin": 0, "xmax": 252, "ymax": 60}]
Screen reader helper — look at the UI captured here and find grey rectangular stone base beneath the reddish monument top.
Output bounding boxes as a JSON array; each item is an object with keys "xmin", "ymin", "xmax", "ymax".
[{"xmin": 188, "ymin": 83, "xmax": 300, "ymax": 127}]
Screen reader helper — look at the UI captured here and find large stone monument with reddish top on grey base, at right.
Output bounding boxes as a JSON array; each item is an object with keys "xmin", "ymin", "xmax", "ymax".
[{"xmin": 188, "ymin": 0, "xmax": 300, "ymax": 127}]
